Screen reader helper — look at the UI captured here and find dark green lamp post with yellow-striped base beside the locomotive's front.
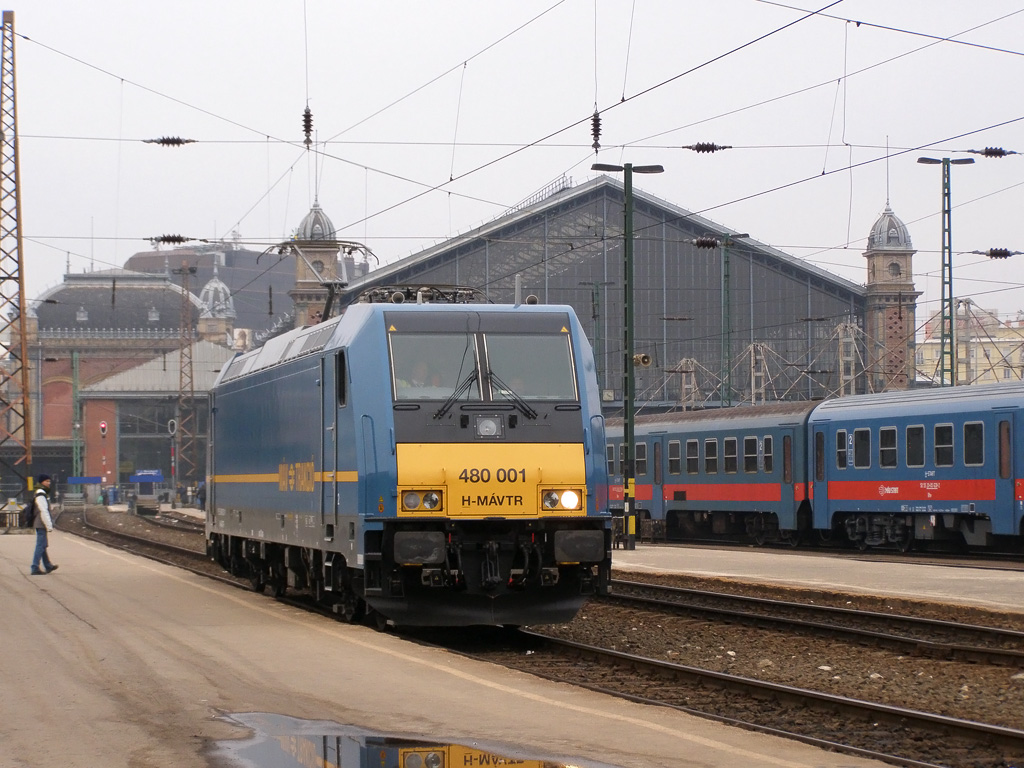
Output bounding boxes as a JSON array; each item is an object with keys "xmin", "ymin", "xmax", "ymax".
[{"xmin": 591, "ymin": 163, "xmax": 665, "ymax": 549}]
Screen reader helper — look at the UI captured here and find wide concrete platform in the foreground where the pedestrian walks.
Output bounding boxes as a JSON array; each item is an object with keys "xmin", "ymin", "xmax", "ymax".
[{"xmin": 0, "ymin": 531, "xmax": 881, "ymax": 768}]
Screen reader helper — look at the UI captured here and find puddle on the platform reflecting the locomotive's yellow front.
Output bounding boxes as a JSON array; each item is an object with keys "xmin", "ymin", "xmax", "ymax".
[{"xmin": 214, "ymin": 713, "xmax": 614, "ymax": 768}]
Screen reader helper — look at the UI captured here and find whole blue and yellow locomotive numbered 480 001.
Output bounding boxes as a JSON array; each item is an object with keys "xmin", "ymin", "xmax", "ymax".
[{"xmin": 207, "ymin": 294, "xmax": 611, "ymax": 626}]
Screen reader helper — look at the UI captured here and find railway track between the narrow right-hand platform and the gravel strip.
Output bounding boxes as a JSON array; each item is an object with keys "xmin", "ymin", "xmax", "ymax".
[{"xmin": 604, "ymin": 580, "xmax": 1024, "ymax": 668}]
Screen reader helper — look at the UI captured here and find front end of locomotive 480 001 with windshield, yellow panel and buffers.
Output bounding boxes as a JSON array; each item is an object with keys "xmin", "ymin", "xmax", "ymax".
[{"xmin": 366, "ymin": 307, "xmax": 610, "ymax": 625}]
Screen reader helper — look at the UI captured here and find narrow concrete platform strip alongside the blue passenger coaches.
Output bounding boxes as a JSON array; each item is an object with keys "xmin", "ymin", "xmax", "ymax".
[{"xmin": 611, "ymin": 544, "xmax": 1024, "ymax": 613}]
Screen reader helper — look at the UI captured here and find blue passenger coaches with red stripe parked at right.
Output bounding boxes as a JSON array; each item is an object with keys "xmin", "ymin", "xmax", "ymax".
[{"xmin": 606, "ymin": 384, "xmax": 1024, "ymax": 550}]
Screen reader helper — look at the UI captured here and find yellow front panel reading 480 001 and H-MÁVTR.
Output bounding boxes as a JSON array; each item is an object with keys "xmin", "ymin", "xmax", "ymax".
[{"xmin": 397, "ymin": 442, "xmax": 587, "ymax": 517}]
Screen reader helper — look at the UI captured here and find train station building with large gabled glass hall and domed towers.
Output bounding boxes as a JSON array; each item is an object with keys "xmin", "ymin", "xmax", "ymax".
[{"xmin": 6, "ymin": 176, "xmax": 920, "ymax": 493}]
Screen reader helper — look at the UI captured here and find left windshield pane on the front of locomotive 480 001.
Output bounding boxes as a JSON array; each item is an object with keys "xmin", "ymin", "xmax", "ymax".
[{"xmin": 388, "ymin": 332, "xmax": 480, "ymax": 400}]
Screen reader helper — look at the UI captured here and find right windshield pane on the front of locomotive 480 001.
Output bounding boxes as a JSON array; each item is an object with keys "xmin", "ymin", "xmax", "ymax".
[{"xmin": 483, "ymin": 333, "xmax": 579, "ymax": 400}]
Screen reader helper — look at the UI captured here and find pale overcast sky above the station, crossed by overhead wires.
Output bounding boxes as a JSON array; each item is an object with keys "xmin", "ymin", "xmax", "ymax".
[{"xmin": 14, "ymin": 0, "xmax": 1024, "ymax": 325}]
